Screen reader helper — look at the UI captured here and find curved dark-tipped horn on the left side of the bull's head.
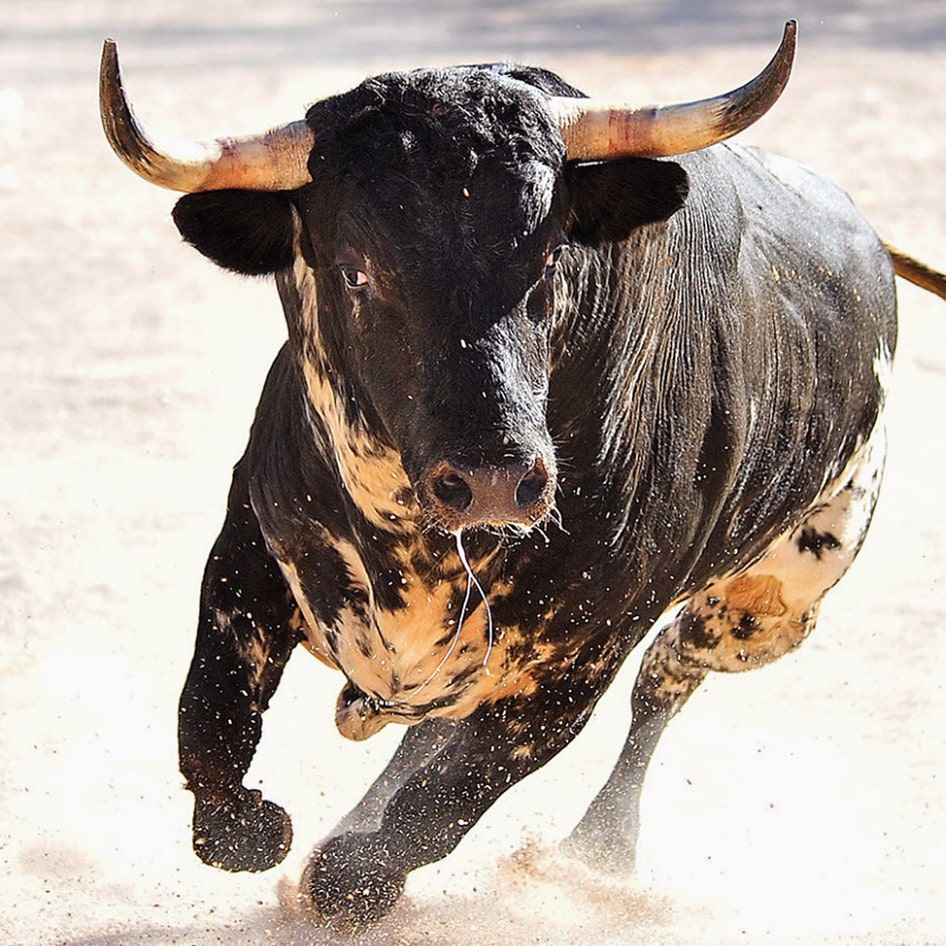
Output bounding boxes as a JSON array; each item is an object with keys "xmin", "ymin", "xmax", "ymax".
[{"xmin": 99, "ymin": 39, "xmax": 315, "ymax": 194}]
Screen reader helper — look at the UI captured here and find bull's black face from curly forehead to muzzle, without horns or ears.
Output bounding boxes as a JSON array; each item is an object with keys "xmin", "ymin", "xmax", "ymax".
[{"xmin": 297, "ymin": 70, "xmax": 566, "ymax": 530}]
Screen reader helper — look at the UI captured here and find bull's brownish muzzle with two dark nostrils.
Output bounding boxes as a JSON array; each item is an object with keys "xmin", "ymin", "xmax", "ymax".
[{"xmin": 419, "ymin": 456, "xmax": 555, "ymax": 531}]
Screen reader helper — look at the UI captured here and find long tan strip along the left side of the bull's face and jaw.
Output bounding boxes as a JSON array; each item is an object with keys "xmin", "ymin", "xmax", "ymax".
[{"xmin": 293, "ymin": 229, "xmax": 417, "ymax": 530}]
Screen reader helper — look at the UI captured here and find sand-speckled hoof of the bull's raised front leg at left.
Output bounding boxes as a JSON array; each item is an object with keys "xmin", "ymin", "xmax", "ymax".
[{"xmin": 194, "ymin": 791, "xmax": 292, "ymax": 871}]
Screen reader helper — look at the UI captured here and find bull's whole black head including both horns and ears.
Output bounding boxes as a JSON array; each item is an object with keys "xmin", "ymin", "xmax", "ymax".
[{"xmin": 101, "ymin": 23, "xmax": 794, "ymax": 530}]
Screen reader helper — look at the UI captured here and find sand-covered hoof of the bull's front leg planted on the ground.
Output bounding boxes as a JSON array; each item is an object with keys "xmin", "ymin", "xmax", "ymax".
[{"xmin": 300, "ymin": 832, "xmax": 407, "ymax": 929}]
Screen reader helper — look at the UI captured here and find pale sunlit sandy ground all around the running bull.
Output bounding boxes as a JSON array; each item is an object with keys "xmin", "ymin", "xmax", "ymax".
[{"xmin": 0, "ymin": 0, "xmax": 946, "ymax": 946}]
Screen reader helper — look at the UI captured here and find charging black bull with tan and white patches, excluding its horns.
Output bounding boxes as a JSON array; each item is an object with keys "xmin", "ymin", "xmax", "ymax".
[{"xmin": 99, "ymin": 27, "xmax": 940, "ymax": 922}]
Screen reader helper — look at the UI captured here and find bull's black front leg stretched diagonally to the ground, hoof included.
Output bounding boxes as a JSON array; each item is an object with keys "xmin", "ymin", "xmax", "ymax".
[{"xmin": 300, "ymin": 656, "xmax": 600, "ymax": 926}]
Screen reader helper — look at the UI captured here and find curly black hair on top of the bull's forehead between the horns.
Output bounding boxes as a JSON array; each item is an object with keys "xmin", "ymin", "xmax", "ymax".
[{"xmin": 308, "ymin": 67, "xmax": 564, "ymax": 229}]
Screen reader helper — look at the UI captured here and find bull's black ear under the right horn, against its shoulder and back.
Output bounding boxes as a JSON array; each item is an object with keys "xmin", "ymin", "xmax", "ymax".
[{"xmin": 565, "ymin": 158, "xmax": 690, "ymax": 246}]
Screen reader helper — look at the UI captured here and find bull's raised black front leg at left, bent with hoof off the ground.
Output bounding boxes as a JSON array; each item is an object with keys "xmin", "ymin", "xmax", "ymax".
[{"xmin": 178, "ymin": 458, "xmax": 300, "ymax": 870}]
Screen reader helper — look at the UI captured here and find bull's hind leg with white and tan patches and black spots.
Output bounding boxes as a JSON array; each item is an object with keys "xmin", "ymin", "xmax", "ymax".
[{"xmin": 565, "ymin": 432, "xmax": 884, "ymax": 873}]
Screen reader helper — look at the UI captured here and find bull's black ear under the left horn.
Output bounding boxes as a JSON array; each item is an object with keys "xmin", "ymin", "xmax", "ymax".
[{"xmin": 172, "ymin": 190, "xmax": 294, "ymax": 276}]
